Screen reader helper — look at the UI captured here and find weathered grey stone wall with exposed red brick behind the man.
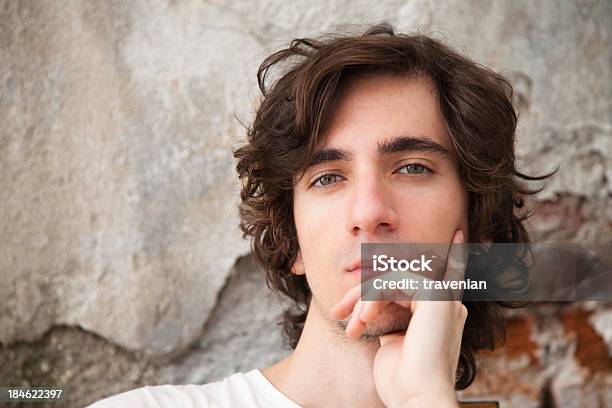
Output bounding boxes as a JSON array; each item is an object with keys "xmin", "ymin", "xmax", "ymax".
[{"xmin": 0, "ymin": 0, "xmax": 612, "ymax": 407}]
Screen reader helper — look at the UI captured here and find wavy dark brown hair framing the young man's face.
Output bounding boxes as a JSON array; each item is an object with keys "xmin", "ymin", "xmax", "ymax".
[{"xmin": 234, "ymin": 23, "xmax": 552, "ymax": 389}]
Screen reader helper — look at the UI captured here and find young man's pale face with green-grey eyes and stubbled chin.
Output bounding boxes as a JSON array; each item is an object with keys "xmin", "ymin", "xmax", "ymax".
[{"xmin": 293, "ymin": 75, "xmax": 468, "ymax": 338}]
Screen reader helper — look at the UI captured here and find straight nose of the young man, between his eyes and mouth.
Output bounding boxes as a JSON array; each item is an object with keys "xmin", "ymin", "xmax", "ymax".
[{"xmin": 347, "ymin": 175, "xmax": 398, "ymax": 242}]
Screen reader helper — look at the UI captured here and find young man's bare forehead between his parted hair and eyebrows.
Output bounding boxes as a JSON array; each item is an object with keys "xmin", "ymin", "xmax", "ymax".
[{"xmin": 320, "ymin": 75, "xmax": 452, "ymax": 151}]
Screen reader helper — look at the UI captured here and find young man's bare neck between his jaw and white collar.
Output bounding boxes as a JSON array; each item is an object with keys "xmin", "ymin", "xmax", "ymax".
[{"xmin": 262, "ymin": 302, "xmax": 384, "ymax": 407}]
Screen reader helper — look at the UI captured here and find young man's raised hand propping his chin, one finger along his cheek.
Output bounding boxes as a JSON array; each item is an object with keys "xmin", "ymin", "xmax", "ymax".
[{"xmin": 332, "ymin": 231, "xmax": 467, "ymax": 407}]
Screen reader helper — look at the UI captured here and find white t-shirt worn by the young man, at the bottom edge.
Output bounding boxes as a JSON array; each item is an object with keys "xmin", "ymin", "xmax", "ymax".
[{"xmin": 88, "ymin": 369, "xmax": 300, "ymax": 408}]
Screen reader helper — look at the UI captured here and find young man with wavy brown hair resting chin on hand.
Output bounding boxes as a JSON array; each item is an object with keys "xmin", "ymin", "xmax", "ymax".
[{"xmin": 88, "ymin": 25, "xmax": 537, "ymax": 408}]
